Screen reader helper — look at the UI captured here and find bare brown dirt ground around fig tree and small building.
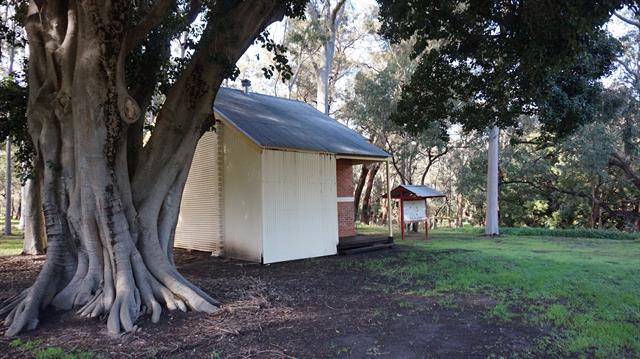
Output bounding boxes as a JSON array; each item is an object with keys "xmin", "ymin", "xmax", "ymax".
[{"xmin": 0, "ymin": 248, "xmax": 544, "ymax": 358}]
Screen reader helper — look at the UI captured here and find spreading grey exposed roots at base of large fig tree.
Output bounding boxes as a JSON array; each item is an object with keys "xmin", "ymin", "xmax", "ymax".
[{"xmin": 0, "ymin": 239, "xmax": 218, "ymax": 336}]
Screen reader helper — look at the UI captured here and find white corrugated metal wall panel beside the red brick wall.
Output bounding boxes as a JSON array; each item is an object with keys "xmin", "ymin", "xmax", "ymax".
[{"xmin": 262, "ymin": 150, "xmax": 338, "ymax": 263}]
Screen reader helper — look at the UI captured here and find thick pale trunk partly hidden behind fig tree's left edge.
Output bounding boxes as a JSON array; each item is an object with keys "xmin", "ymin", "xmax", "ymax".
[{"xmin": 22, "ymin": 170, "xmax": 47, "ymax": 255}]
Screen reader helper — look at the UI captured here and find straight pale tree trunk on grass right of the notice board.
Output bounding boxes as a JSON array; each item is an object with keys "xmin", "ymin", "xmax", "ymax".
[{"xmin": 484, "ymin": 126, "xmax": 500, "ymax": 236}]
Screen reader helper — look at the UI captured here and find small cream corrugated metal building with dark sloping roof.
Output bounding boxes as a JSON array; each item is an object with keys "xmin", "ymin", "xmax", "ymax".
[{"xmin": 174, "ymin": 88, "xmax": 391, "ymax": 263}]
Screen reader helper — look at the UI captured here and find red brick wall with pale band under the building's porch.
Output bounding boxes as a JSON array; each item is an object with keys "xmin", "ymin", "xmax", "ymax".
[{"xmin": 336, "ymin": 160, "xmax": 356, "ymax": 237}]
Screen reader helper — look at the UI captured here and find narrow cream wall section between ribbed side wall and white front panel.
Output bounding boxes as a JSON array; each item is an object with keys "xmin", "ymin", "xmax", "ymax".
[{"xmin": 222, "ymin": 126, "xmax": 262, "ymax": 262}]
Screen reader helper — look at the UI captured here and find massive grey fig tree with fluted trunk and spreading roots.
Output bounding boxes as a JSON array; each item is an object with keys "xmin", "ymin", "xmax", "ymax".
[{"xmin": 0, "ymin": 0, "xmax": 304, "ymax": 336}]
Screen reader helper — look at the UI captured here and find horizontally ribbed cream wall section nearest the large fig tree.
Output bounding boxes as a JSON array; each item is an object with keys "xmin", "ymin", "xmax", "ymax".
[{"xmin": 174, "ymin": 131, "xmax": 223, "ymax": 255}]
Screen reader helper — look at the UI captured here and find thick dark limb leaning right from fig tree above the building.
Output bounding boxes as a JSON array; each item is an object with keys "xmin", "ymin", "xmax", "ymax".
[{"xmin": 132, "ymin": 0, "xmax": 286, "ymax": 207}]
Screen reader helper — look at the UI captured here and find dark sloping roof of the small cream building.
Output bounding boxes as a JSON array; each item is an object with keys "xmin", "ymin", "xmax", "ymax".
[{"xmin": 214, "ymin": 88, "xmax": 389, "ymax": 158}]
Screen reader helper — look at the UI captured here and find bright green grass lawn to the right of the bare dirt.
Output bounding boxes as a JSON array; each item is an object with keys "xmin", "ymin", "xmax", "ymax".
[{"xmin": 351, "ymin": 227, "xmax": 640, "ymax": 358}]
